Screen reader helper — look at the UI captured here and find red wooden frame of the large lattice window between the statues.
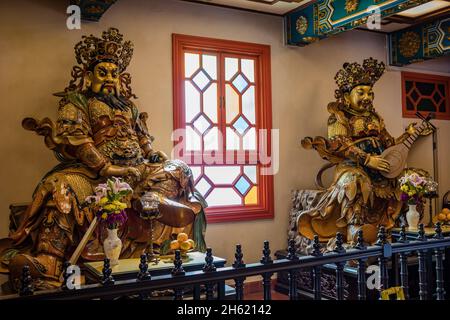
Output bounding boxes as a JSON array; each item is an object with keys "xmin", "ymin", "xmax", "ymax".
[{"xmin": 172, "ymin": 34, "xmax": 274, "ymax": 223}]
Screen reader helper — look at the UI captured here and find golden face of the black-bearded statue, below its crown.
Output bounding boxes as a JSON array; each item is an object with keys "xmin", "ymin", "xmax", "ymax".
[{"xmin": 87, "ymin": 62, "xmax": 120, "ymax": 95}]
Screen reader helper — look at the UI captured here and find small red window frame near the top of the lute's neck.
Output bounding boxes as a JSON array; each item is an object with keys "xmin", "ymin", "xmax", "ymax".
[{"xmin": 401, "ymin": 72, "xmax": 450, "ymax": 120}]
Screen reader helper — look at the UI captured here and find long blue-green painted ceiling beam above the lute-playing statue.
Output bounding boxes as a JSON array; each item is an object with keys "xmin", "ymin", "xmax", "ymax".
[{"xmin": 285, "ymin": 0, "xmax": 430, "ymax": 46}]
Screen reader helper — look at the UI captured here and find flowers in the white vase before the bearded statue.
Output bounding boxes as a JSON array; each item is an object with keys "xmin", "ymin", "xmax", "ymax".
[{"xmin": 86, "ymin": 177, "xmax": 133, "ymax": 229}]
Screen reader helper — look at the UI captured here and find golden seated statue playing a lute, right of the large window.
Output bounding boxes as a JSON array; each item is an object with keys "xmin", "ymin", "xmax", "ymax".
[{"xmin": 297, "ymin": 58, "xmax": 425, "ymax": 251}]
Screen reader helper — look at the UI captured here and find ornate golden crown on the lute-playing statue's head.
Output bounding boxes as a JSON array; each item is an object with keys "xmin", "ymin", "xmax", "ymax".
[{"xmin": 334, "ymin": 57, "xmax": 385, "ymax": 93}]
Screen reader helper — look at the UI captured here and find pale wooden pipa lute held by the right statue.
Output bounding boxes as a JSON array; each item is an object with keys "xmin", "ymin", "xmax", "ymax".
[{"xmin": 381, "ymin": 113, "xmax": 436, "ymax": 179}]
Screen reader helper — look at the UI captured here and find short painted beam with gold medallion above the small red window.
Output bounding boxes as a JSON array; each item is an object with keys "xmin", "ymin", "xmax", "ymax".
[{"xmin": 389, "ymin": 17, "xmax": 450, "ymax": 66}]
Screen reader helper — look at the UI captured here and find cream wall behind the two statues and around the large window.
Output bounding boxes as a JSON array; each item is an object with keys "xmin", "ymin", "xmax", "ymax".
[{"xmin": 0, "ymin": 0, "xmax": 450, "ymax": 262}]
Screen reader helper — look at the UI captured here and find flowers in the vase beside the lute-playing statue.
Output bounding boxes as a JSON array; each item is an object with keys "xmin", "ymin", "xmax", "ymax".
[{"xmin": 399, "ymin": 172, "xmax": 437, "ymax": 204}]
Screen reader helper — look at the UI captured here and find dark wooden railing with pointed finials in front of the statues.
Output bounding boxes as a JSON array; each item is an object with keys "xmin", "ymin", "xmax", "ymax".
[{"xmin": 0, "ymin": 223, "xmax": 450, "ymax": 300}]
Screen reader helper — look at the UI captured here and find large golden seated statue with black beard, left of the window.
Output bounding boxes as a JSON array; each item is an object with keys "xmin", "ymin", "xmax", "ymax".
[{"xmin": 0, "ymin": 28, "xmax": 206, "ymax": 288}]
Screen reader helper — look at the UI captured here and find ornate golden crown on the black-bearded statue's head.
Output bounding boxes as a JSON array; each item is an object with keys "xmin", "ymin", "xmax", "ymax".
[{"xmin": 75, "ymin": 28, "xmax": 133, "ymax": 72}]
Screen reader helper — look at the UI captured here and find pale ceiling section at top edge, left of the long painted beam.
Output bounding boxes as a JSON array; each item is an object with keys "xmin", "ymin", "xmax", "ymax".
[{"xmin": 187, "ymin": 0, "xmax": 311, "ymax": 15}]
